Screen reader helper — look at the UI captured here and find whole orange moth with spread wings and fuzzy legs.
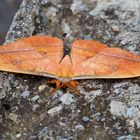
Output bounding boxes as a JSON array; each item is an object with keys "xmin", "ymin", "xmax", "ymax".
[{"xmin": 0, "ymin": 36, "xmax": 140, "ymax": 93}]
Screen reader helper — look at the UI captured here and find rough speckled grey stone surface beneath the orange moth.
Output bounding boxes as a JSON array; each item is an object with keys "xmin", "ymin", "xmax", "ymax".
[{"xmin": 0, "ymin": 0, "xmax": 140, "ymax": 140}]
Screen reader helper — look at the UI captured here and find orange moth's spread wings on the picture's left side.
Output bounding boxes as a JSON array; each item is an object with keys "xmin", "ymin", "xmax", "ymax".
[{"xmin": 0, "ymin": 36, "xmax": 64, "ymax": 77}]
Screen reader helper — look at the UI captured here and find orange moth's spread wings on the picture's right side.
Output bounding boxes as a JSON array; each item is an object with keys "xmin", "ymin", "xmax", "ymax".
[{"xmin": 71, "ymin": 40, "xmax": 140, "ymax": 79}]
